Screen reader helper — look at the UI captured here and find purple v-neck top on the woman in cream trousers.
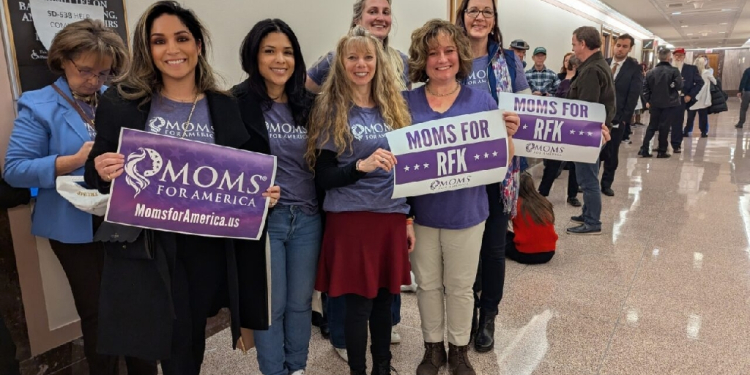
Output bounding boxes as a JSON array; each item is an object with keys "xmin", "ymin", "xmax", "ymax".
[{"xmin": 404, "ymin": 86, "xmax": 497, "ymax": 229}]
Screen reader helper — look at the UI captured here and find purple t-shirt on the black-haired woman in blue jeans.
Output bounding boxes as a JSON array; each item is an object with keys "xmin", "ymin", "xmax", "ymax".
[{"xmin": 263, "ymin": 103, "xmax": 318, "ymax": 215}]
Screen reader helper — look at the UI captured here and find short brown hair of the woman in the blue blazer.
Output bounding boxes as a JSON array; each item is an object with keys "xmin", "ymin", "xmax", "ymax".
[{"xmin": 47, "ymin": 19, "xmax": 130, "ymax": 76}]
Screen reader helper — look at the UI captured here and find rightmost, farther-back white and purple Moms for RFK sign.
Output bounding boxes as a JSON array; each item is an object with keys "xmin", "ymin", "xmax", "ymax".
[{"xmin": 499, "ymin": 93, "xmax": 607, "ymax": 163}]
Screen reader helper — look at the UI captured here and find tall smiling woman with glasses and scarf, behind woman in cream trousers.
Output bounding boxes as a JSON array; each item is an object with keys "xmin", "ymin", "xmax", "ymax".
[{"xmin": 456, "ymin": 0, "xmax": 531, "ymax": 353}]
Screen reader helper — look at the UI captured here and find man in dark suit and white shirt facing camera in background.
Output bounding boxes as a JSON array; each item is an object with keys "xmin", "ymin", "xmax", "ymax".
[{"xmin": 601, "ymin": 34, "xmax": 643, "ymax": 197}]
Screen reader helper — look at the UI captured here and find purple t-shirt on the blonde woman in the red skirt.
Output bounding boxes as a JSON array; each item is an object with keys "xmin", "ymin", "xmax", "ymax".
[{"xmin": 321, "ymin": 106, "xmax": 409, "ymax": 214}]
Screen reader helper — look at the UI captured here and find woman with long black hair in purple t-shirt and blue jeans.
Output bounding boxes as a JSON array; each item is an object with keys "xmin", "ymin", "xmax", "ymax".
[{"xmin": 232, "ymin": 19, "xmax": 322, "ymax": 375}]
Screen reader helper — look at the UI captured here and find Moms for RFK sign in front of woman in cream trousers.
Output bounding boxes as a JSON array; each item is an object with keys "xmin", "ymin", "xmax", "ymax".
[{"xmin": 386, "ymin": 111, "xmax": 508, "ymax": 198}]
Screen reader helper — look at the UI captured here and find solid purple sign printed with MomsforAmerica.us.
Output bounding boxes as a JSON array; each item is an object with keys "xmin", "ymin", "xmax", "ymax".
[{"xmin": 105, "ymin": 128, "xmax": 276, "ymax": 240}]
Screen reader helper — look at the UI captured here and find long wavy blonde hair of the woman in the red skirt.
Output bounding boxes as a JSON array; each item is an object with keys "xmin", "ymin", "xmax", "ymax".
[{"xmin": 305, "ymin": 26, "xmax": 411, "ymax": 168}]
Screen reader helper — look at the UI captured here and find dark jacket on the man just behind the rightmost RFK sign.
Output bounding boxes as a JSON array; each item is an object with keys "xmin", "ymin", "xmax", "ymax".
[{"xmin": 568, "ymin": 52, "xmax": 616, "ymax": 128}]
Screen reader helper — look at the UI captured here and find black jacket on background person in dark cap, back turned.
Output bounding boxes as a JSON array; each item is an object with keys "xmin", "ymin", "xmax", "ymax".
[{"xmin": 643, "ymin": 61, "xmax": 683, "ymax": 108}]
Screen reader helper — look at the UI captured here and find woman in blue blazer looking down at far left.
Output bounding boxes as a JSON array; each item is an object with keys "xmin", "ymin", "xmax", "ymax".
[{"xmin": 4, "ymin": 20, "xmax": 157, "ymax": 375}]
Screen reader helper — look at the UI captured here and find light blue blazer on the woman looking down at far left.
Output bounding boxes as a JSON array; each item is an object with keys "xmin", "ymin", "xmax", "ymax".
[{"xmin": 4, "ymin": 78, "xmax": 106, "ymax": 243}]
